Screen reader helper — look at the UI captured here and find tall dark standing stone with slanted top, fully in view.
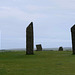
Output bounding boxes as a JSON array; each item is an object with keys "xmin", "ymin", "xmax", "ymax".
[{"xmin": 26, "ymin": 22, "xmax": 34, "ymax": 55}]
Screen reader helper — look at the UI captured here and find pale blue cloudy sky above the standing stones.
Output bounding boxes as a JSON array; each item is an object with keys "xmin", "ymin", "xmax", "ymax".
[{"xmin": 0, "ymin": 0, "xmax": 75, "ymax": 49}]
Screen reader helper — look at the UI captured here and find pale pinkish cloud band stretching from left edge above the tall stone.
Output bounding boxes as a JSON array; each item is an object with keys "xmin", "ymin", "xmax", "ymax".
[{"xmin": 0, "ymin": 7, "xmax": 45, "ymax": 21}]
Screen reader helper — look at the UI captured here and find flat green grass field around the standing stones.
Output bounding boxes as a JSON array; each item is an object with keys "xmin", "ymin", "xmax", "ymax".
[{"xmin": 0, "ymin": 51, "xmax": 75, "ymax": 75}]
